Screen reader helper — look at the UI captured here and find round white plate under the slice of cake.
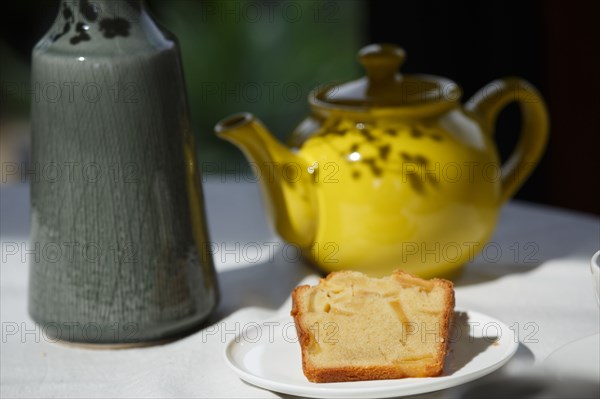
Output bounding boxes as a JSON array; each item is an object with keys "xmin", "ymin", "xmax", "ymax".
[{"xmin": 225, "ymin": 311, "xmax": 519, "ymax": 398}]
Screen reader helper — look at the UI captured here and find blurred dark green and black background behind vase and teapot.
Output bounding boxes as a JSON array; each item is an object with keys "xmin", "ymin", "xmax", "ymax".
[{"xmin": 0, "ymin": 0, "xmax": 600, "ymax": 214}]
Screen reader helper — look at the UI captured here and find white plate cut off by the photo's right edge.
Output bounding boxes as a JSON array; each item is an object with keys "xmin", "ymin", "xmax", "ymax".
[{"xmin": 544, "ymin": 334, "xmax": 600, "ymax": 381}]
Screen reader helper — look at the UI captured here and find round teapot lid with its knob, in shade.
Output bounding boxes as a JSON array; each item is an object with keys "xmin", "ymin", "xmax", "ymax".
[{"xmin": 310, "ymin": 44, "xmax": 461, "ymax": 111}]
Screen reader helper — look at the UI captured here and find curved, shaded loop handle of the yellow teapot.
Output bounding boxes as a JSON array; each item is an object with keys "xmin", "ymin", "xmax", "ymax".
[{"xmin": 465, "ymin": 77, "xmax": 549, "ymax": 203}]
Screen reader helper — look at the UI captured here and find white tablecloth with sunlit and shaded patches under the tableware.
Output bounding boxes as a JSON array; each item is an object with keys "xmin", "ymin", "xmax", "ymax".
[{"xmin": 0, "ymin": 180, "xmax": 600, "ymax": 398}]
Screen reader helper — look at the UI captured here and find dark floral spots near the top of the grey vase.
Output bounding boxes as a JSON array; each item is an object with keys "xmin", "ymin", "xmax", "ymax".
[{"xmin": 51, "ymin": 0, "xmax": 131, "ymax": 45}]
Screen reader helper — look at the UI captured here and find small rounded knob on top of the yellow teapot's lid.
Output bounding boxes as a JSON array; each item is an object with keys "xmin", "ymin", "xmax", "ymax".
[{"xmin": 358, "ymin": 43, "xmax": 406, "ymax": 83}]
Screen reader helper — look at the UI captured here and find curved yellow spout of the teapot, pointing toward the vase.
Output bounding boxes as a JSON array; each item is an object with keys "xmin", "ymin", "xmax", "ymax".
[{"xmin": 215, "ymin": 113, "xmax": 317, "ymax": 248}]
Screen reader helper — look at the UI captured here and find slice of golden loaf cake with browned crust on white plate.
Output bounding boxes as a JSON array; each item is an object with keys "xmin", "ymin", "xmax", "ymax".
[{"xmin": 291, "ymin": 271, "xmax": 454, "ymax": 382}]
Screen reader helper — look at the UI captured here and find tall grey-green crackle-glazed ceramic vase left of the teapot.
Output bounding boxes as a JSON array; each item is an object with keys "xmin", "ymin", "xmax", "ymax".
[{"xmin": 29, "ymin": 0, "xmax": 218, "ymax": 345}]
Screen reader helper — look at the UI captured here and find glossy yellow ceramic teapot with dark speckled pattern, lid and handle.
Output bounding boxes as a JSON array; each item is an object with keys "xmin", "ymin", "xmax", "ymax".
[{"xmin": 215, "ymin": 44, "xmax": 549, "ymax": 278}]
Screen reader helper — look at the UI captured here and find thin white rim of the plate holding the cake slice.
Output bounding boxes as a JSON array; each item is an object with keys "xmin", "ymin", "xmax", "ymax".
[{"xmin": 224, "ymin": 309, "xmax": 519, "ymax": 398}]
